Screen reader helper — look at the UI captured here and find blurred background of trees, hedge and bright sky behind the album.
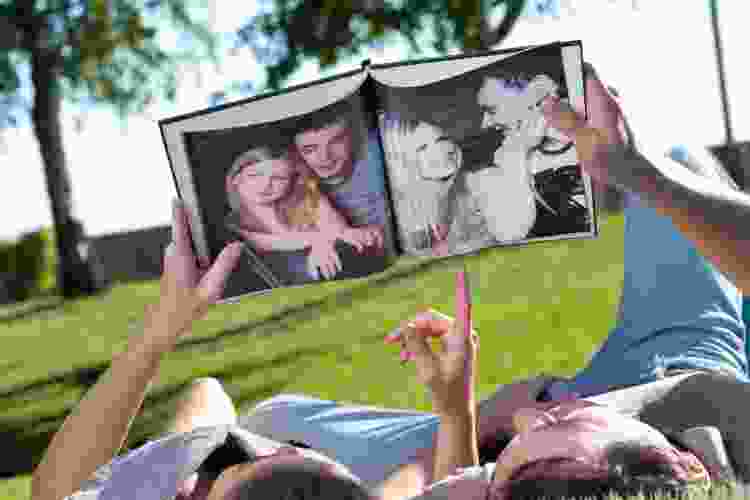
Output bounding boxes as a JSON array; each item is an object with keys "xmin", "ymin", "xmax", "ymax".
[{"xmin": 0, "ymin": 0, "xmax": 750, "ymax": 302}]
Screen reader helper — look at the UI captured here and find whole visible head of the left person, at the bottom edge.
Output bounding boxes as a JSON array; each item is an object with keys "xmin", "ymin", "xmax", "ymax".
[{"xmin": 207, "ymin": 448, "xmax": 371, "ymax": 500}]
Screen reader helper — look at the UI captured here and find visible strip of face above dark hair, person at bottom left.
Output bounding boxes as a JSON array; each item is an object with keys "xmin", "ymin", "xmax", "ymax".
[{"xmin": 206, "ymin": 447, "xmax": 348, "ymax": 500}]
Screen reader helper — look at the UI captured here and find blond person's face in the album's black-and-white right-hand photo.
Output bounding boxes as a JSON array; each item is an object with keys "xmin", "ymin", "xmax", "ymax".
[{"xmin": 413, "ymin": 122, "xmax": 461, "ymax": 179}]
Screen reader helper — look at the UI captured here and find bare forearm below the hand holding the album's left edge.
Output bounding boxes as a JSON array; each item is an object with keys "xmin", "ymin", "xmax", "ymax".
[{"xmin": 31, "ymin": 328, "xmax": 165, "ymax": 500}]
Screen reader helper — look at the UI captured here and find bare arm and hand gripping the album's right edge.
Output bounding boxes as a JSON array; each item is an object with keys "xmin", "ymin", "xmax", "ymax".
[{"xmin": 544, "ymin": 74, "xmax": 750, "ymax": 290}]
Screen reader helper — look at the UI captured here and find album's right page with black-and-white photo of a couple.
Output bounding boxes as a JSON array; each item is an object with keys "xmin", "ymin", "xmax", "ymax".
[{"xmin": 371, "ymin": 42, "xmax": 597, "ymax": 256}]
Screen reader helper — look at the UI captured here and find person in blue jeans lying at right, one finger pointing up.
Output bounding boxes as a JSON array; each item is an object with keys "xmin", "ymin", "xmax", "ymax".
[{"xmin": 239, "ymin": 63, "xmax": 750, "ymax": 500}]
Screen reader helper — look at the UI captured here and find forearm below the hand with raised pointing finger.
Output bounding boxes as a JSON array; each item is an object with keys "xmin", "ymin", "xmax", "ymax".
[{"xmin": 432, "ymin": 410, "xmax": 479, "ymax": 482}]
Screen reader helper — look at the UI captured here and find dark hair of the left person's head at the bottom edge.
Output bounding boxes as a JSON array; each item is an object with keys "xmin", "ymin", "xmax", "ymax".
[{"xmin": 236, "ymin": 464, "xmax": 374, "ymax": 500}]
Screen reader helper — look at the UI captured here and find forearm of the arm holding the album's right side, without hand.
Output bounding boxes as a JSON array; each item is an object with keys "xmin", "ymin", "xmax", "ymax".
[{"xmin": 607, "ymin": 147, "xmax": 750, "ymax": 290}]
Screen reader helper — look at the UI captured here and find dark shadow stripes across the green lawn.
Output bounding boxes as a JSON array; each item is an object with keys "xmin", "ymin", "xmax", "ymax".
[{"xmin": 0, "ymin": 254, "xmax": 470, "ymax": 478}]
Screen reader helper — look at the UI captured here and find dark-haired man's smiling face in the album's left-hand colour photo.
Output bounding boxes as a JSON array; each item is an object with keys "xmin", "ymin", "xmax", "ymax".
[{"xmin": 294, "ymin": 120, "xmax": 353, "ymax": 179}]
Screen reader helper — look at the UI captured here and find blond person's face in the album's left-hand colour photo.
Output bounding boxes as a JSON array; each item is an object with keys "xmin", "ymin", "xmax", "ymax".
[{"xmin": 232, "ymin": 158, "xmax": 294, "ymax": 205}]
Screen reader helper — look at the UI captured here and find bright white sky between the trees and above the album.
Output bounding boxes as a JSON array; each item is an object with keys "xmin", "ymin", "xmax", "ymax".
[{"xmin": 0, "ymin": 0, "xmax": 750, "ymax": 240}]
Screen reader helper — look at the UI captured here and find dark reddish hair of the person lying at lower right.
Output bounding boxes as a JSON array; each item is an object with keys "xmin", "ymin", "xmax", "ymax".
[{"xmin": 504, "ymin": 442, "xmax": 705, "ymax": 500}]
